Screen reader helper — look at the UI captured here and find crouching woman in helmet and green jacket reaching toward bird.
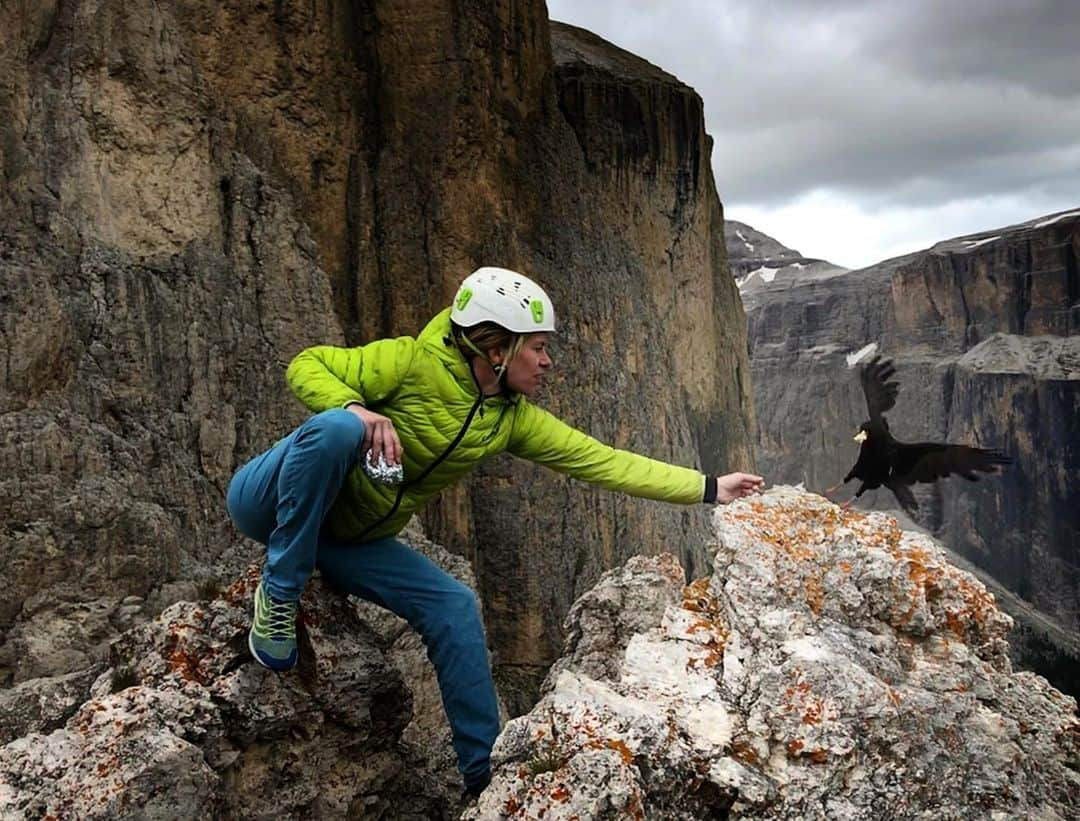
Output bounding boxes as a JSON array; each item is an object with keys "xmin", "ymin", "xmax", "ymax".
[{"xmin": 228, "ymin": 268, "xmax": 762, "ymax": 794}]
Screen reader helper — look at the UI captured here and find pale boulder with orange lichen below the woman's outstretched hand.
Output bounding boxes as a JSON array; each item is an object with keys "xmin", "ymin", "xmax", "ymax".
[{"xmin": 465, "ymin": 487, "xmax": 1080, "ymax": 820}]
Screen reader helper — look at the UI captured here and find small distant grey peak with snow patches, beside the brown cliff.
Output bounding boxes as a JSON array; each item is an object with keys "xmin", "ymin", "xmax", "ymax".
[{"xmin": 724, "ymin": 219, "xmax": 848, "ymax": 293}]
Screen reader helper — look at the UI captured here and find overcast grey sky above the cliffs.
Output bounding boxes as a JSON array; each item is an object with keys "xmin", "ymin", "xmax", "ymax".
[{"xmin": 548, "ymin": 0, "xmax": 1080, "ymax": 268}]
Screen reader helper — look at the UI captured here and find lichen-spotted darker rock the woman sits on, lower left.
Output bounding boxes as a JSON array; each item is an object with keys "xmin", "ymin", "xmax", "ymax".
[{"xmin": 0, "ymin": 522, "xmax": 473, "ymax": 819}]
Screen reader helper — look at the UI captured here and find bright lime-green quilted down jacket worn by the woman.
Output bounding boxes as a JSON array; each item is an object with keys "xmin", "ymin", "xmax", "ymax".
[{"xmin": 286, "ymin": 308, "xmax": 705, "ymax": 541}]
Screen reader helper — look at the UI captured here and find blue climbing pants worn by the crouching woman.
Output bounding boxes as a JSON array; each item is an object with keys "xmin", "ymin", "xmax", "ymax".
[{"xmin": 227, "ymin": 409, "xmax": 499, "ymax": 785}]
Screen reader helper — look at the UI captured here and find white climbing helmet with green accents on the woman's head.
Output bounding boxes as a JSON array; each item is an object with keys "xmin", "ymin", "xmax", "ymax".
[{"xmin": 450, "ymin": 267, "xmax": 555, "ymax": 334}]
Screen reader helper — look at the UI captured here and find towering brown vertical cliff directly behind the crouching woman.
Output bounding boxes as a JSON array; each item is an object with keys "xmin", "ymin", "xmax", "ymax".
[{"xmin": 0, "ymin": 0, "xmax": 753, "ymax": 704}]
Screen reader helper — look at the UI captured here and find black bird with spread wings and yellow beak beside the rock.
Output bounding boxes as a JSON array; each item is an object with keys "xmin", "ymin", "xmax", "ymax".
[{"xmin": 825, "ymin": 356, "xmax": 1012, "ymax": 516}]
